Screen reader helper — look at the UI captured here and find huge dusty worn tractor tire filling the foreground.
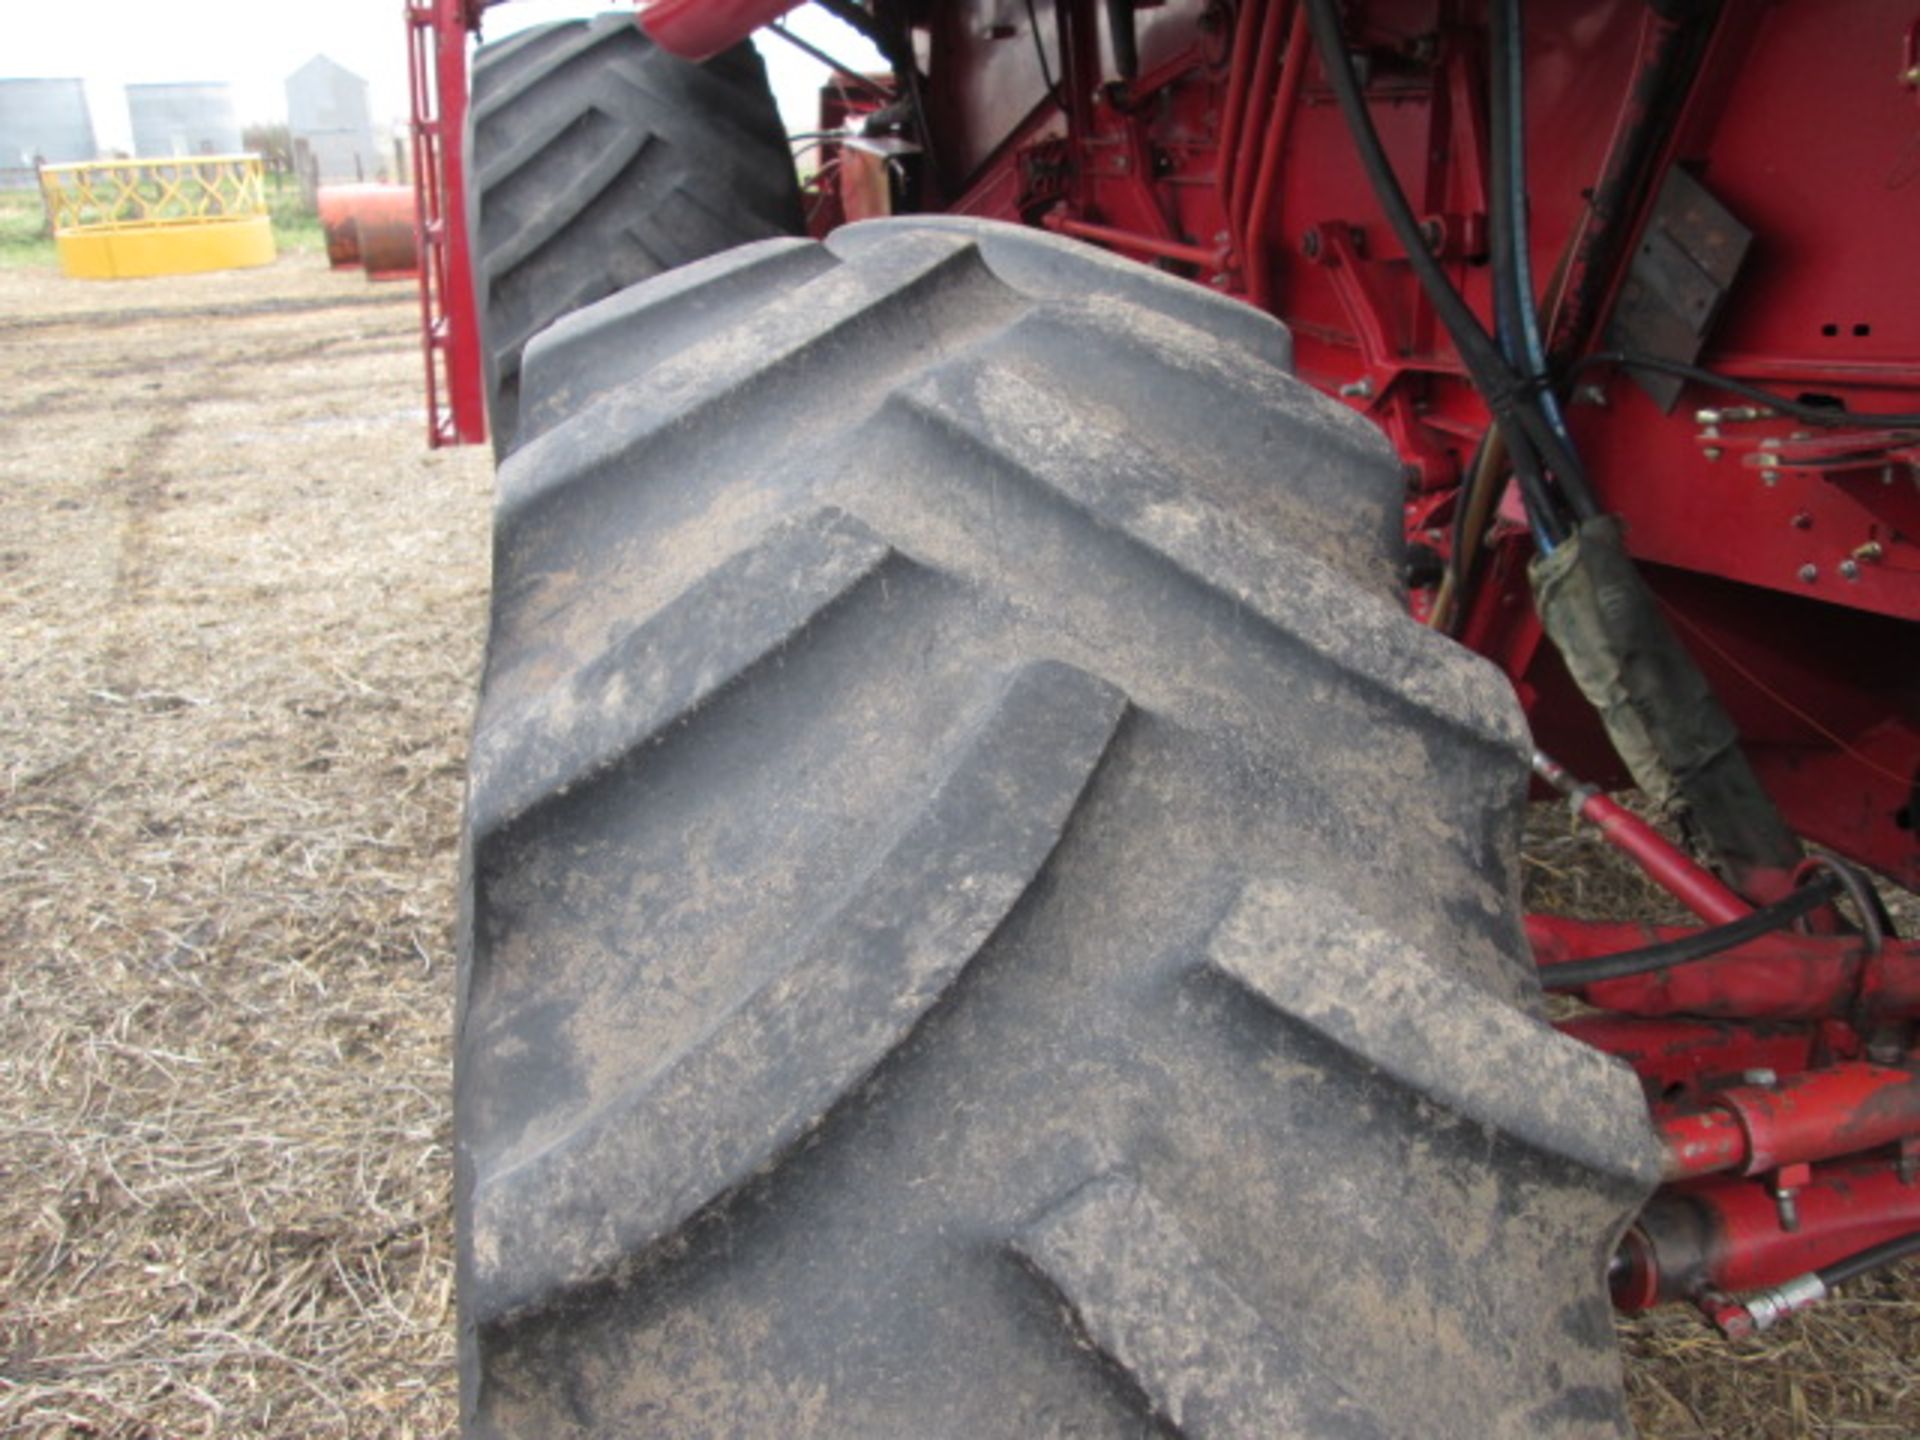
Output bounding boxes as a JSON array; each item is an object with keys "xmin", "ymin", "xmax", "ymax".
[{"xmin": 457, "ymin": 221, "xmax": 1659, "ymax": 1440}]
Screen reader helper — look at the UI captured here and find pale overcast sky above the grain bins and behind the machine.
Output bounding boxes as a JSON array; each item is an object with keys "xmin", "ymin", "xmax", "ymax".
[{"xmin": 0, "ymin": 0, "xmax": 879, "ymax": 150}]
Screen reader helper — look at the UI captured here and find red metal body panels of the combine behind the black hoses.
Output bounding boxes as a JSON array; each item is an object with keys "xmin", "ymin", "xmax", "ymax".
[{"xmin": 856, "ymin": 0, "xmax": 1920, "ymax": 885}]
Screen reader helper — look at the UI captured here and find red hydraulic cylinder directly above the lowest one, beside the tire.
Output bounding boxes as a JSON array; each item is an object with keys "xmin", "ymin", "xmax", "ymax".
[{"xmin": 1657, "ymin": 1062, "xmax": 1920, "ymax": 1181}]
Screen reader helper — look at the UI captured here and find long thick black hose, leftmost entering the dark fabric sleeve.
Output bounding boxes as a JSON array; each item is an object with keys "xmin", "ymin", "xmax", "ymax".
[{"xmin": 1306, "ymin": 0, "xmax": 1578, "ymax": 543}]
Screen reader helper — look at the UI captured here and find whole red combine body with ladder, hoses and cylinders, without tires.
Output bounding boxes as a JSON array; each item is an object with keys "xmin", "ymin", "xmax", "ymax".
[{"xmin": 424, "ymin": 0, "xmax": 1920, "ymax": 1436}]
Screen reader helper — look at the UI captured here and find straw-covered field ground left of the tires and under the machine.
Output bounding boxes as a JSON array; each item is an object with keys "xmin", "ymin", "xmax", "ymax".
[{"xmin": 0, "ymin": 257, "xmax": 1920, "ymax": 1440}]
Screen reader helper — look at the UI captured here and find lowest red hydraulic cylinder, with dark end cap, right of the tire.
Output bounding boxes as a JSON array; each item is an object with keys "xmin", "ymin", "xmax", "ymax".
[{"xmin": 1613, "ymin": 1162, "xmax": 1920, "ymax": 1311}]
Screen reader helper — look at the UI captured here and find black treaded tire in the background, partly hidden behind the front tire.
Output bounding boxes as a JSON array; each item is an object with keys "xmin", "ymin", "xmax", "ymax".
[{"xmin": 467, "ymin": 12, "xmax": 803, "ymax": 455}]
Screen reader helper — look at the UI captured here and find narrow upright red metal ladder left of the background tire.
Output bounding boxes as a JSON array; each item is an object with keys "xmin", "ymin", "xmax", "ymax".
[{"xmin": 407, "ymin": 0, "xmax": 486, "ymax": 447}]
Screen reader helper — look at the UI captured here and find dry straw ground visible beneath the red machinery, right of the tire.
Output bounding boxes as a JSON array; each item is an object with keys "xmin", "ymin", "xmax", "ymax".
[{"xmin": 1526, "ymin": 803, "xmax": 1920, "ymax": 1440}]
